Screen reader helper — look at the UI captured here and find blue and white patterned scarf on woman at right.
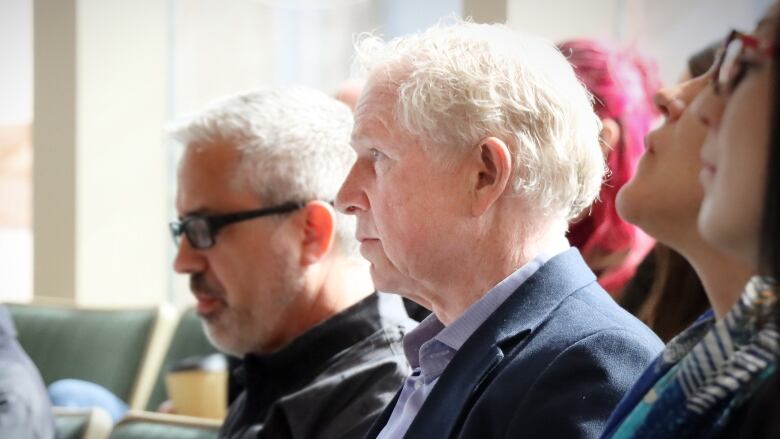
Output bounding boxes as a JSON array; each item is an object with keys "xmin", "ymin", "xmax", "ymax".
[{"xmin": 609, "ymin": 276, "xmax": 780, "ymax": 439}]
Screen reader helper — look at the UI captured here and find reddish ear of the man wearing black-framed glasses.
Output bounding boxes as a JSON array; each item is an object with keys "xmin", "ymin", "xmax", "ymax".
[{"xmin": 301, "ymin": 201, "xmax": 336, "ymax": 266}]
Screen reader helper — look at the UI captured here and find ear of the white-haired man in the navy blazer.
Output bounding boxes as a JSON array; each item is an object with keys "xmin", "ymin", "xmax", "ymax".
[{"xmin": 471, "ymin": 137, "xmax": 512, "ymax": 216}]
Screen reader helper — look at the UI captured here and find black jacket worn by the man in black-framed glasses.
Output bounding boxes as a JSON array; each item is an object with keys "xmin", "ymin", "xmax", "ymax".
[{"xmin": 220, "ymin": 293, "xmax": 416, "ymax": 439}]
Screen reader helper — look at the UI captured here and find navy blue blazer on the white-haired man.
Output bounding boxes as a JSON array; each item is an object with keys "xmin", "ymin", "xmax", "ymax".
[{"xmin": 367, "ymin": 249, "xmax": 663, "ymax": 439}]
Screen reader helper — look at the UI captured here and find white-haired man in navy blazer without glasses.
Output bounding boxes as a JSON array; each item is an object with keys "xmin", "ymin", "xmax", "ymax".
[{"xmin": 336, "ymin": 22, "xmax": 662, "ymax": 438}]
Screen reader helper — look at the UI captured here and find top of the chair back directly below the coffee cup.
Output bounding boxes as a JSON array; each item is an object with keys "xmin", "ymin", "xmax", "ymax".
[{"xmin": 110, "ymin": 411, "xmax": 221, "ymax": 439}]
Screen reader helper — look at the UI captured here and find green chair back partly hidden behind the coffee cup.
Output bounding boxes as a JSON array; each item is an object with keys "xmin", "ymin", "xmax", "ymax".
[{"xmin": 146, "ymin": 308, "xmax": 217, "ymax": 411}]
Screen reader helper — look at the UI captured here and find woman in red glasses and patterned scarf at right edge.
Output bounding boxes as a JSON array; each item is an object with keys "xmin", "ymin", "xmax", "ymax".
[{"xmin": 604, "ymin": 6, "xmax": 780, "ymax": 438}]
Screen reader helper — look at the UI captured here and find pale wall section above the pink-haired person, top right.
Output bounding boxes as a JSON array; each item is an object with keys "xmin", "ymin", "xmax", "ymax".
[{"xmin": 507, "ymin": 0, "xmax": 772, "ymax": 83}]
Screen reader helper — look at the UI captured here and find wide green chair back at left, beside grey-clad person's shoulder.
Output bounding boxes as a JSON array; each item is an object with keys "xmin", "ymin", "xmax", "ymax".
[{"xmin": 8, "ymin": 304, "xmax": 157, "ymax": 402}]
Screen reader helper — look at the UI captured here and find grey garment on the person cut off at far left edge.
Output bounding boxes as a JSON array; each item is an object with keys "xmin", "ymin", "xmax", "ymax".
[{"xmin": 0, "ymin": 305, "xmax": 55, "ymax": 439}]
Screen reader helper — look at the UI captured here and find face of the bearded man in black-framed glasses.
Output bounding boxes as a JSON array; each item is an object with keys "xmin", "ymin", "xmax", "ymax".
[{"xmin": 174, "ymin": 145, "xmax": 301, "ymax": 356}]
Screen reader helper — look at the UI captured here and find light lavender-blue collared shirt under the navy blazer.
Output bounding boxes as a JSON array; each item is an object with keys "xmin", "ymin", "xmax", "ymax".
[{"xmin": 377, "ymin": 254, "xmax": 555, "ymax": 439}]
